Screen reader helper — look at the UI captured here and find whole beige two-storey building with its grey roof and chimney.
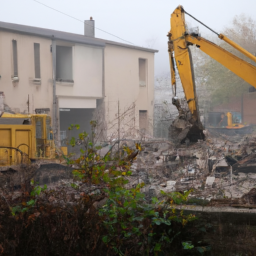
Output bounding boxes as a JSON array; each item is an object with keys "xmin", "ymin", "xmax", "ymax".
[{"xmin": 0, "ymin": 20, "xmax": 157, "ymax": 146}]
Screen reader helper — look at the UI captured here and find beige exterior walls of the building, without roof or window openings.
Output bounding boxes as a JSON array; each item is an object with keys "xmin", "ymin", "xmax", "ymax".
[{"xmin": 0, "ymin": 30, "xmax": 154, "ymax": 142}]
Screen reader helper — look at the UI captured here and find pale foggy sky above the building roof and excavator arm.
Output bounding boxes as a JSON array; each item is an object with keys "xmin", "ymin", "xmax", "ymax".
[{"xmin": 0, "ymin": 0, "xmax": 256, "ymax": 75}]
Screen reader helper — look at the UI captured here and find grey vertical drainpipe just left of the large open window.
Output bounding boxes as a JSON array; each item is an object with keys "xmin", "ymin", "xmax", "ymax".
[{"xmin": 52, "ymin": 37, "xmax": 59, "ymax": 146}]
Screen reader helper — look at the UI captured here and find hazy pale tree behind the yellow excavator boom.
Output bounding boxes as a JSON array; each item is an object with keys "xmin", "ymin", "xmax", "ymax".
[{"xmin": 192, "ymin": 15, "xmax": 256, "ymax": 106}]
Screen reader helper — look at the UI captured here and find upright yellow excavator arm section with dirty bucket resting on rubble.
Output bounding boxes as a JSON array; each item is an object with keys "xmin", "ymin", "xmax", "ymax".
[{"xmin": 168, "ymin": 6, "xmax": 204, "ymax": 144}]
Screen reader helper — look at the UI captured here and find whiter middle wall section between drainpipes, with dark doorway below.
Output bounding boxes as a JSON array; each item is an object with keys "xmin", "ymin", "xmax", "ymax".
[{"xmin": 56, "ymin": 42, "xmax": 104, "ymax": 146}]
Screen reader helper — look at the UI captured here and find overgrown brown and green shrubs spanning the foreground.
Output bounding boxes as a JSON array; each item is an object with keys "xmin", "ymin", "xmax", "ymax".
[{"xmin": 0, "ymin": 122, "xmax": 210, "ymax": 256}]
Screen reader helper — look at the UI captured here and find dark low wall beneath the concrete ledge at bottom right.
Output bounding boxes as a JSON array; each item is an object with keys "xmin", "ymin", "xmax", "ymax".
[{"xmin": 185, "ymin": 211, "xmax": 256, "ymax": 256}]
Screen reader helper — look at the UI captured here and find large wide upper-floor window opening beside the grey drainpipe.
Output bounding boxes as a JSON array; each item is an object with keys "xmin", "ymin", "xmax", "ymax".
[{"xmin": 56, "ymin": 46, "xmax": 74, "ymax": 82}]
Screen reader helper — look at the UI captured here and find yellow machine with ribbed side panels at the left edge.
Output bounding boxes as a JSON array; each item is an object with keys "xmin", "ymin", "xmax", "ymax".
[{"xmin": 0, "ymin": 112, "xmax": 55, "ymax": 166}]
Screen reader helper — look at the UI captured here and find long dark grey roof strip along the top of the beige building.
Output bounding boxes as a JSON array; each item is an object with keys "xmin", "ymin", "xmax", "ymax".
[{"xmin": 0, "ymin": 21, "xmax": 158, "ymax": 53}]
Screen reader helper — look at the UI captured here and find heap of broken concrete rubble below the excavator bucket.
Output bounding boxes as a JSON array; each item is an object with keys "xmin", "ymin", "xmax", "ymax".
[{"xmin": 130, "ymin": 131, "xmax": 256, "ymax": 207}]
